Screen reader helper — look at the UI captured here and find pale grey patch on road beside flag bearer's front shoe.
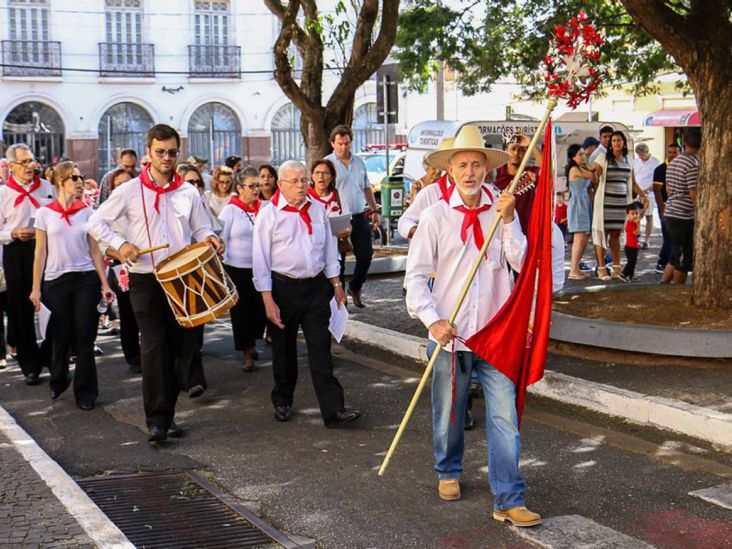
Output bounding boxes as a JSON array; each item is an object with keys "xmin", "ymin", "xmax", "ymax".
[{"xmin": 511, "ymin": 515, "xmax": 653, "ymax": 549}]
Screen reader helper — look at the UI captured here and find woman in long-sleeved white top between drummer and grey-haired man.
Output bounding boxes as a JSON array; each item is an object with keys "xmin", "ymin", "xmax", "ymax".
[{"xmin": 219, "ymin": 168, "xmax": 265, "ymax": 372}]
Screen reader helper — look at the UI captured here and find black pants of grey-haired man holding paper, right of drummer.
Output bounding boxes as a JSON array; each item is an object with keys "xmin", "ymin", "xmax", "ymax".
[{"xmin": 269, "ymin": 273, "xmax": 345, "ymax": 422}]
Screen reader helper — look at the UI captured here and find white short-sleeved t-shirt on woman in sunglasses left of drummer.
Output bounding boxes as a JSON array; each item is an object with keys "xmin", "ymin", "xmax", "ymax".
[{"xmin": 35, "ymin": 207, "xmax": 94, "ymax": 280}]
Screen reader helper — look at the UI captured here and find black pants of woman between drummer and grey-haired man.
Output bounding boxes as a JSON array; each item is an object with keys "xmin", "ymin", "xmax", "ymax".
[{"xmin": 224, "ymin": 265, "xmax": 266, "ymax": 351}]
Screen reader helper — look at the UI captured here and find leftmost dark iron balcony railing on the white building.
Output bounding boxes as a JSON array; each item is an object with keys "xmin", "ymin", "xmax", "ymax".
[{"xmin": 2, "ymin": 40, "xmax": 61, "ymax": 76}]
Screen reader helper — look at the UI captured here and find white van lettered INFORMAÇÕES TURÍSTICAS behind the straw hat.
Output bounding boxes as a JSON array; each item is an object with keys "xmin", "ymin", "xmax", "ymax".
[{"xmin": 404, "ymin": 120, "xmax": 634, "ymax": 191}]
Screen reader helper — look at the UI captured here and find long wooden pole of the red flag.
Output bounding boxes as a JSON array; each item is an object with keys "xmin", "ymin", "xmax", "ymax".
[{"xmin": 378, "ymin": 97, "xmax": 557, "ymax": 477}]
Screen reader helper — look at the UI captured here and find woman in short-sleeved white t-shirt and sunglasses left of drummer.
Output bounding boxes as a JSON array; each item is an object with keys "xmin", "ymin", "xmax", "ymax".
[{"xmin": 30, "ymin": 161, "xmax": 114, "ymax": 410}]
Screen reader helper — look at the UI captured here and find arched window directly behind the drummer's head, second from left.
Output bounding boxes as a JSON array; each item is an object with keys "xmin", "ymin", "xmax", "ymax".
[{"xmin": 98, "ymin": 103, "xmax": 153, "ymax": 174}]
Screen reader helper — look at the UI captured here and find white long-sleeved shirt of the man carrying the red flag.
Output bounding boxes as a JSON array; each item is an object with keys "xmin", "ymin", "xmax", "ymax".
[{"xmin": 405, "ymin": 187, "xmax": 526, "ymax": 351}]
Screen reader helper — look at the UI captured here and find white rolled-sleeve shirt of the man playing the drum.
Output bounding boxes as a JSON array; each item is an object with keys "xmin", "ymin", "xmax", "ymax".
[{"xmin": 89, "ymin": 177, "xmax": 214, "ymax": 274}]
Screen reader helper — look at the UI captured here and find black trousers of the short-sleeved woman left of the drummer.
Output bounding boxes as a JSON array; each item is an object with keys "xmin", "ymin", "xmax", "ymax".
[{"xmin": 42, "ymin": 271, "xmax": 102, "ymax": 404}]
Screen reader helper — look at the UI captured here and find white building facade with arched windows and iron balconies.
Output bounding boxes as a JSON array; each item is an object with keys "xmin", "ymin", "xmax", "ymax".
[{"xmin": 0, "ymin": 0, "xmax": 378, "ymax": 175}]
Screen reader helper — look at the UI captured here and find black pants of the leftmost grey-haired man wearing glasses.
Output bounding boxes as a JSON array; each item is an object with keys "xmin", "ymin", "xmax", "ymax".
[{"xmin": 3, "ymin": 240, "xmax": 53, "ymax": 376}]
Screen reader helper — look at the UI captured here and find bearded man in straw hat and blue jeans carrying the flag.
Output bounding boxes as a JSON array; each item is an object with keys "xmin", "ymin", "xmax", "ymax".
[{"xmin": 406, "ymin": 126, "xmax": 541, "ymax": 527}]
